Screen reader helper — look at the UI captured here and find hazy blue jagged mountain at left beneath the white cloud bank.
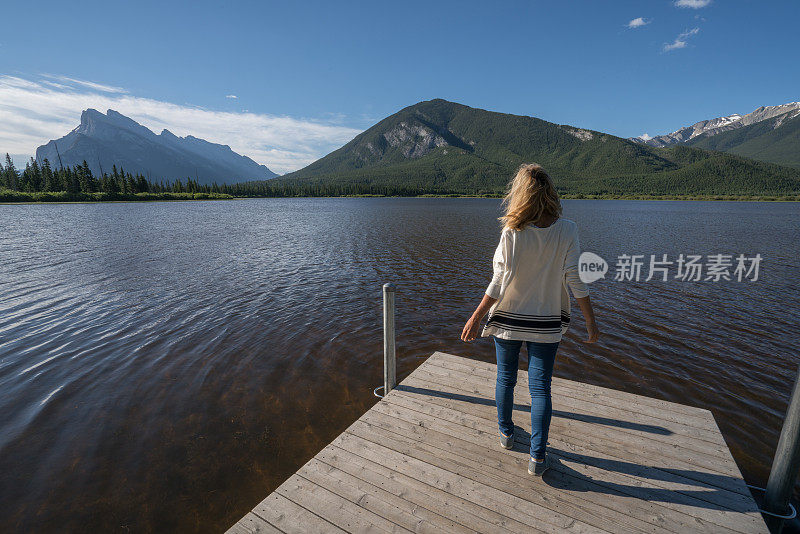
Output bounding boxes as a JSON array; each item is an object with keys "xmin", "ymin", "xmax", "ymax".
[{"xmin": 36, "ymin": 109, "xmax": 277, "ymax": 184}]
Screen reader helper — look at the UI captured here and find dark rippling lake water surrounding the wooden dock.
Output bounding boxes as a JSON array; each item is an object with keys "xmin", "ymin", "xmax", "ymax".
[{"xmin": 0, "ymin": 199, "xmax": 800, "ymax": 532}]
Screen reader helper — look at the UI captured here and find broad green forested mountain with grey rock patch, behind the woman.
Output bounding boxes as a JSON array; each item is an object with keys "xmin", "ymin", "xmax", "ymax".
[{"xmin": 279, "ymin": 99, "xmax": 800, "ymax": 194}]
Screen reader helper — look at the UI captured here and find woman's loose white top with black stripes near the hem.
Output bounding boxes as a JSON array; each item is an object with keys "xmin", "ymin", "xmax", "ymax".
[{"xmin": 481, "ymin": 218, "xmax": 589, "ymax": 343}]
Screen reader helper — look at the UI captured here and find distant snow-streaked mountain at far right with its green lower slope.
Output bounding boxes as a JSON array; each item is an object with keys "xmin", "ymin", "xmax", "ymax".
[{"xmin": 632, "ymin": 102, "xmax": 800, "ymax": 168}]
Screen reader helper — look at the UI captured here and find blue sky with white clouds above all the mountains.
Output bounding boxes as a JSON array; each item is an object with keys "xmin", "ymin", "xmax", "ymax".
[{"xmin": 0, "ymin": 0, "xmax": 800, "ymax": 172}]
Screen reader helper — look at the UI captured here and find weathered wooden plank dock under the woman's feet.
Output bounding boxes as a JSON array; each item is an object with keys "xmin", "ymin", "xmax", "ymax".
[{"xmin": 229, "ymin": 352, "xmax": 768, "ymax": 534}]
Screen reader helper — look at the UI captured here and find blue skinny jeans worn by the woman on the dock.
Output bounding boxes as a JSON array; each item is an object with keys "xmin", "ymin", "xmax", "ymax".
[{"xmin": 492, "ymin": 336, "xmax": 558, "ymax": 459}]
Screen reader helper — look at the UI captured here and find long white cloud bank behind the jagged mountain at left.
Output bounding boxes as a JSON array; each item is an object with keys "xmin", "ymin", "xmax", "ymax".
[{"xmin": 0, "ymin": 75, "xmax": 361, "ymax": 174}]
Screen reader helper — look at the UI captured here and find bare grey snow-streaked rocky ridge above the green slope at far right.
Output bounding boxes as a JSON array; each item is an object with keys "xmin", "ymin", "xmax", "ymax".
[{"xmin": 631, "ymin": 102, "xmax": 800, "ymax": 147}]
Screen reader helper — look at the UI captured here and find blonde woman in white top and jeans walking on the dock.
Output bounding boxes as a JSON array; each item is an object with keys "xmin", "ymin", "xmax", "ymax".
[{"xmin": 461, "ymin": 164, "xmax": 599, "ymax": 476}]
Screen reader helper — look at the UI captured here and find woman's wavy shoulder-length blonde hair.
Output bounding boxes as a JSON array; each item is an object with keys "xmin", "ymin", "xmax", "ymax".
[{"xmin": 499, "ymin": 163, "xmax": 561, "ymax": 230}]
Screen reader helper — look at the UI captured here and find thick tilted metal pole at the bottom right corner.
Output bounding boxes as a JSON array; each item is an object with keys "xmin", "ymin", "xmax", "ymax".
[{"xmin": 764, "ymin": 368, "xmax": 800, "ymax": 533}]
